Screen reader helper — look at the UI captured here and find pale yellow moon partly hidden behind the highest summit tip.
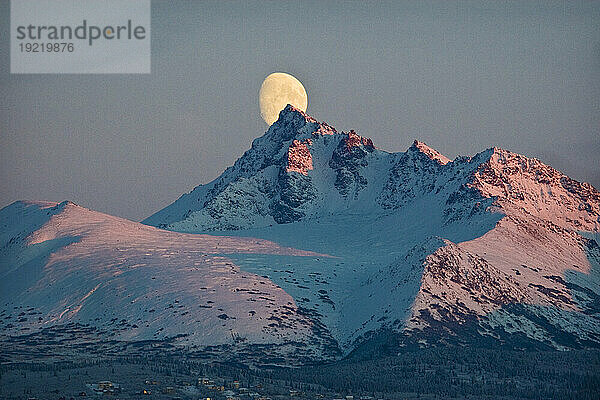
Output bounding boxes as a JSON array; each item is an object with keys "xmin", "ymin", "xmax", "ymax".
[{"xmin": 258, "ymin": 72, "xmax": 308, "ymax": 126}]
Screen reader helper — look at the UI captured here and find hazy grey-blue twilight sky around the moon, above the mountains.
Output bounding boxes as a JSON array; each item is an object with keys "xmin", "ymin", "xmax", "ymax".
[{"xmin": 0, "ymin": 0, "xmax": 600, "ymax": 220}]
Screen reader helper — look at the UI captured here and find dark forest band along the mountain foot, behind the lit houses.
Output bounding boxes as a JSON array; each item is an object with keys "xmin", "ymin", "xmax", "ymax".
[{"xmin": 0, "ymin": 347, "xmax": 600, "ymax": 400}]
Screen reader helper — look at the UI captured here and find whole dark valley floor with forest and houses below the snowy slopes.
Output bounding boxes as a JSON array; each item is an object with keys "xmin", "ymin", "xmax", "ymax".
[{"xmin": 0, "ymin": 347, "xmax": 600, "ymax": 400}]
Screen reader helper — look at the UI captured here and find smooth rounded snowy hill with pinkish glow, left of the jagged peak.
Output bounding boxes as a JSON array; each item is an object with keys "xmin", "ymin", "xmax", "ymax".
[{"xmin": 0, "ymin": 202, "xmax": 335, "ymax": 358}]
